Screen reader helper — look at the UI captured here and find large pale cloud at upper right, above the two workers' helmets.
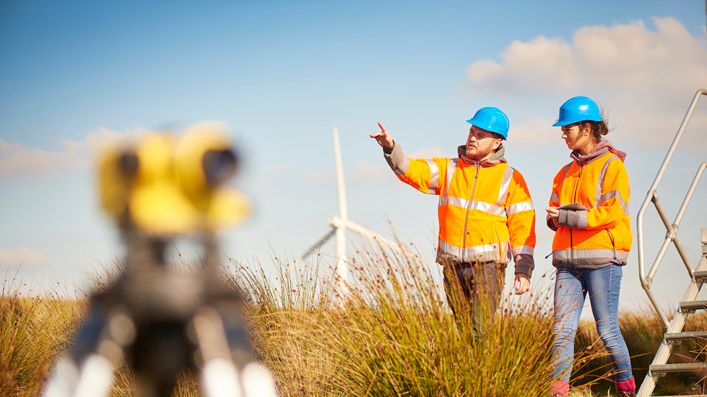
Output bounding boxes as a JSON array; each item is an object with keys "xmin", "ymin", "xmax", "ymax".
[{"xmin": 466, "ymin": 18, "xmax": 707, "ymax": 151}]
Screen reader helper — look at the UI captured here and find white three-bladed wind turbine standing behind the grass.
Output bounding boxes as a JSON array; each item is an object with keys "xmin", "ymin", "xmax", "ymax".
[{"xmin": 301, "ymin": 128, "xmax": 412, "ymax": 302}]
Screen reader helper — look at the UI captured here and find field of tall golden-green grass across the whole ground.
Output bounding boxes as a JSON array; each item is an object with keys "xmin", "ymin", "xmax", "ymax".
[{"xmin": 0, "ymin": 246, "xmax": 707, "ymax": 397}]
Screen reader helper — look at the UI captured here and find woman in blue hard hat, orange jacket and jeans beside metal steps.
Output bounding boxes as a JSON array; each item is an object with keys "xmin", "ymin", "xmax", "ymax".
[{"xmin": 547, "ymin": 97, "xmax": 636, "ymax": 396}]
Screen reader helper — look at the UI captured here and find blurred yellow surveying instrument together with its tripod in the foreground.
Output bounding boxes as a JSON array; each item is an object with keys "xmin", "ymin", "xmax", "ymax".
[{"xmin": 43, "ymin": 124, "xmax": 277, "ymax": 397}]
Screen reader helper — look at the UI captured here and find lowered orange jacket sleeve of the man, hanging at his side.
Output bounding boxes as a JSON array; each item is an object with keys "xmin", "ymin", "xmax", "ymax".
[{"xmin": 506, "ymin": 170, "xmax": 535, "ymax": 277}]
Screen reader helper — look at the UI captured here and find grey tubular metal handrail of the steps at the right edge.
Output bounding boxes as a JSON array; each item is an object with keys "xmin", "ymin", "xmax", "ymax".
[{"xmin": 636, "ymin": 88, "xmax": 707, "ymax": 328}]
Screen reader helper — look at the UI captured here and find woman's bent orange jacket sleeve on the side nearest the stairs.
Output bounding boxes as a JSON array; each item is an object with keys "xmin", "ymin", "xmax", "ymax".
[{"xmin": 559, "ymin": 158, "xmax": 630, "ymax": 230}]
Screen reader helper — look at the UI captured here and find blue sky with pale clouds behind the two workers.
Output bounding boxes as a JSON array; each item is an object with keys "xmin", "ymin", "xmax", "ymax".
[{"xmin": 0, "ymin": 0, "xmax": 707, "ymax": 316}]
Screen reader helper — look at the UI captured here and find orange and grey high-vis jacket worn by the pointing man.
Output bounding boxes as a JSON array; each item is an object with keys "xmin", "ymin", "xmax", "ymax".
[{"xmin": 384, "ymin": 143, "xmax": 535, "ymax": 277}]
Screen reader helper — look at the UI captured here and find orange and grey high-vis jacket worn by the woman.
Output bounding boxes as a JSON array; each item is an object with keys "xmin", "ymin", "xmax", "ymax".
[{"xmin": 548, "ymin": 141, "xmax": 632, "ymax": 268}]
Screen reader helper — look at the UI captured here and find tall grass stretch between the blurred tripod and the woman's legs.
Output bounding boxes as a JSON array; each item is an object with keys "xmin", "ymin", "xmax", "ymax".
[{"xmin": 236, "ymin": 246, "xmax": 588, "ymax": 396}]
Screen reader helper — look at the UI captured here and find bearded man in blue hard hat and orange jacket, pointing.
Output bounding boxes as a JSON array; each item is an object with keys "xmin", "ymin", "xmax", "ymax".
[{"xmin": 371, "ymin": 107, "xmax": 535, "ymax": 324}]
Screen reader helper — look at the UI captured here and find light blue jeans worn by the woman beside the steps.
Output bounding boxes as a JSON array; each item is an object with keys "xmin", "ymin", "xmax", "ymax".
[{"xmin": 553, "ymin": 264, "xmax": 633, "ymax": 382}]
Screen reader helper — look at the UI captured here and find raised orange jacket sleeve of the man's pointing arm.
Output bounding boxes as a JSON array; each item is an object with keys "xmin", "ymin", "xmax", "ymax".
[{"xmin": 383, "ymin": 142, "xmax": 446, "ymax": 195}]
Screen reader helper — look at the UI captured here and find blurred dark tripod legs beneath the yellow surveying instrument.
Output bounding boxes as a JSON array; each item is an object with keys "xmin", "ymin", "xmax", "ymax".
[{"xmin": 44, "ymin": 231, "xmax": 277, "ymax": 397}]
